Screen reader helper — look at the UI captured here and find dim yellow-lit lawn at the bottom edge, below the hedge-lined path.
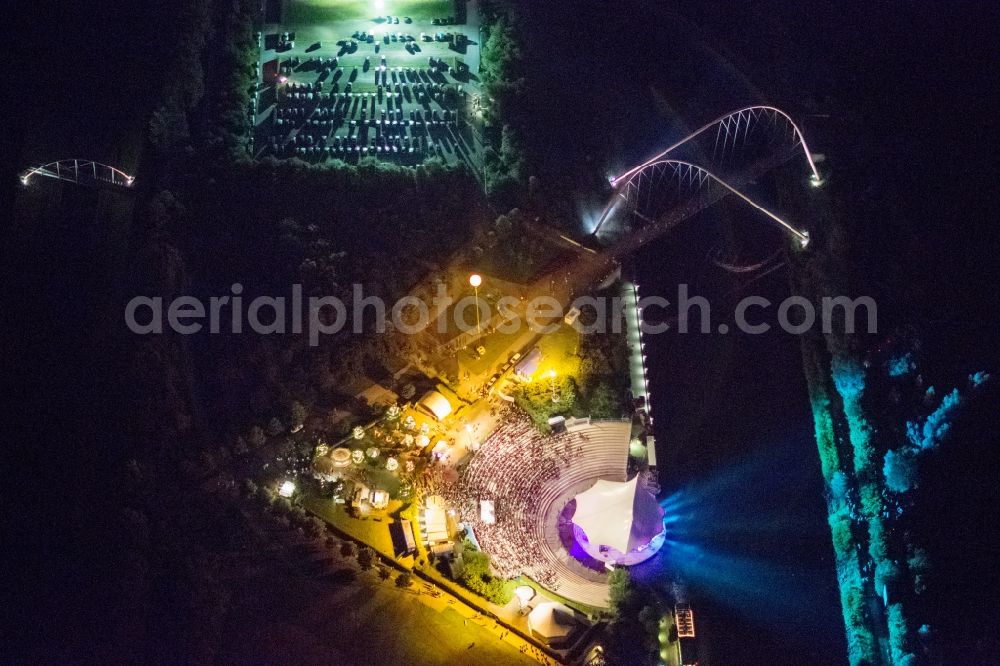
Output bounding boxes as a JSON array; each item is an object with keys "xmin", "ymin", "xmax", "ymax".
[{"xmin": 216, "ymin": 520, "xmax": 535, "ymax": 666}]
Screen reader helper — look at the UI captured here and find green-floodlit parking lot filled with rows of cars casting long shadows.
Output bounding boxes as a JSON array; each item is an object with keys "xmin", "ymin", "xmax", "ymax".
[{"xmin": 254, "ymin": 0, "xmax": 479, "ymax": 163}]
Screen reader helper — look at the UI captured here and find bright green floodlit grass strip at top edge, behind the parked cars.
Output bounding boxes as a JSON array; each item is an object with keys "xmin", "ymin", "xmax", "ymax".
[{"xmin": 284, "ymin": 0, "xmax": 455, "ymax": 27}]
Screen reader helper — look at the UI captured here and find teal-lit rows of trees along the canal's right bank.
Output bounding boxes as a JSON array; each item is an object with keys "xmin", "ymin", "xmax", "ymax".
[{"xmin": 793, "ymin": 195, "xmax": 989, "ymax": 665}]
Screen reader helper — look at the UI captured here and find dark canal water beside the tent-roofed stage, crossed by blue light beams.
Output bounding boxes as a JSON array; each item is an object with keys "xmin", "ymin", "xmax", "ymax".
[{"xmin": 637, "ymin": 210, "xmax": 844, "ymax": 664}]
